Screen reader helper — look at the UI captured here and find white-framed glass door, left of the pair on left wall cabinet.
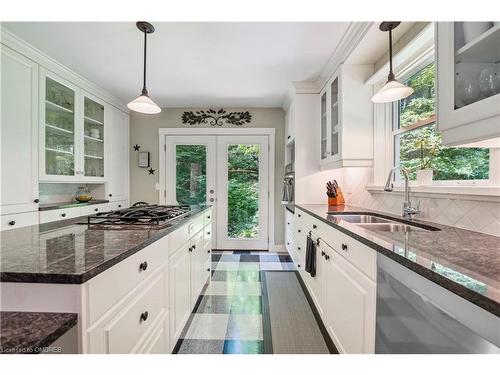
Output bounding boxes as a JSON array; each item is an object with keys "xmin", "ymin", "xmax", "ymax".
[{"xmin": 40, "ymin": 74, "xmax": 78, "ymax": 181}]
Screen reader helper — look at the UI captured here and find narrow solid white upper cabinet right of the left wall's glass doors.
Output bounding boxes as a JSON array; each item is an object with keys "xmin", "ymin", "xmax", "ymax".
[{"xmin": 106, "ymin": 106, "xmax": 129, "ymax": 202}]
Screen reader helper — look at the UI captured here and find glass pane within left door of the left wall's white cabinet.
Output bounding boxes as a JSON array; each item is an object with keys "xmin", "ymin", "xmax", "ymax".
[{"xmin": 45, "ymin": 77, "xmax": 75, "ymax": 176}]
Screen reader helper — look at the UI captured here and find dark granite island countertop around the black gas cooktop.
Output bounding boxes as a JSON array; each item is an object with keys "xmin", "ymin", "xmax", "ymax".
[{"xmin": 0, "ymin": 206, "xmax": 208, "ymax": 284}]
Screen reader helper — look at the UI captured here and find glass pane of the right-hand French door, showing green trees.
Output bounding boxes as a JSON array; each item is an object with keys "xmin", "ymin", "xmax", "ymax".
[{"xmin": 227, "ymin": 144, "xmax": 260, "ymax": 238}]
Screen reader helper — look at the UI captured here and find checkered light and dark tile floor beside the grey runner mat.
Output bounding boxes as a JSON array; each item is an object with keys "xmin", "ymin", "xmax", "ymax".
[{"xmin": 174, "ymin": 251, "xmax": 295, "ymax": 354}]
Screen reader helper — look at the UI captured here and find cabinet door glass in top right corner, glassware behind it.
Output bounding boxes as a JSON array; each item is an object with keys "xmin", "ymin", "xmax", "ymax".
[{"xmin": 453, "ymin": 22, "xmax": 500, "ymax": 109}]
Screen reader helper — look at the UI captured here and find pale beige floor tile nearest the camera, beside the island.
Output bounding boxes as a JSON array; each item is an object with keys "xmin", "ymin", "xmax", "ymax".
[{"xmin": 184, "ymin": 314, "xmax": 229, "ymax": 340}]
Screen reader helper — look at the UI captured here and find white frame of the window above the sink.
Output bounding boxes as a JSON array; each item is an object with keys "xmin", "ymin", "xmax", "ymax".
[{"xmin": 387, "ymin": 56, "xmax": 500, "ymax": 187}]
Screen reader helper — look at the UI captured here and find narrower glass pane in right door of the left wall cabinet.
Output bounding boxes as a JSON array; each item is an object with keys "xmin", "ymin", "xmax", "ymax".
[{"xmin": 83, "ymin": 98, "xmax": 104, "ymax": 177}]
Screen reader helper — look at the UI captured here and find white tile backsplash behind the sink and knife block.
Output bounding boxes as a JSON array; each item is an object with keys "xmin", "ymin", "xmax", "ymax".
[{"xmin": 297, "ymin": 168, "xmax": 500, "ymax": 236}]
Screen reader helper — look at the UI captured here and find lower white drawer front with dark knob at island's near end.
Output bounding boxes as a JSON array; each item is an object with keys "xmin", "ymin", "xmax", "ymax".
[{"xmin": 104, "ymin": 273, "xmax": 167, "ymax": 354}]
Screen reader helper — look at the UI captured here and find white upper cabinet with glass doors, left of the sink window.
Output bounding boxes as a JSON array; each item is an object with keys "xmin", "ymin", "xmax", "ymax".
[{"xmin": 318, "ymin": 65, "xmax": 373, "ymax": 169}]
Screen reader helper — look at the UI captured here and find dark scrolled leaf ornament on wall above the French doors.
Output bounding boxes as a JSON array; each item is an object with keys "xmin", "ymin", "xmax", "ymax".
[{"xmin": 182, "ymin": 109, "xmax": 252, "ymax": 126}]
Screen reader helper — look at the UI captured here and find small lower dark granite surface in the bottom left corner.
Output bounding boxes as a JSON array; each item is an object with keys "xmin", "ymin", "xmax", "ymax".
[{"xmin": 0, "ymin": 311, "xmax": 77, "ymax": 354}]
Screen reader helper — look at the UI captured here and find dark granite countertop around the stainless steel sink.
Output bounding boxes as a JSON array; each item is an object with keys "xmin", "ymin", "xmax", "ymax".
[{"xmin": 295, "ymin": 204, "xmax": 500, "ymax": 316}]
